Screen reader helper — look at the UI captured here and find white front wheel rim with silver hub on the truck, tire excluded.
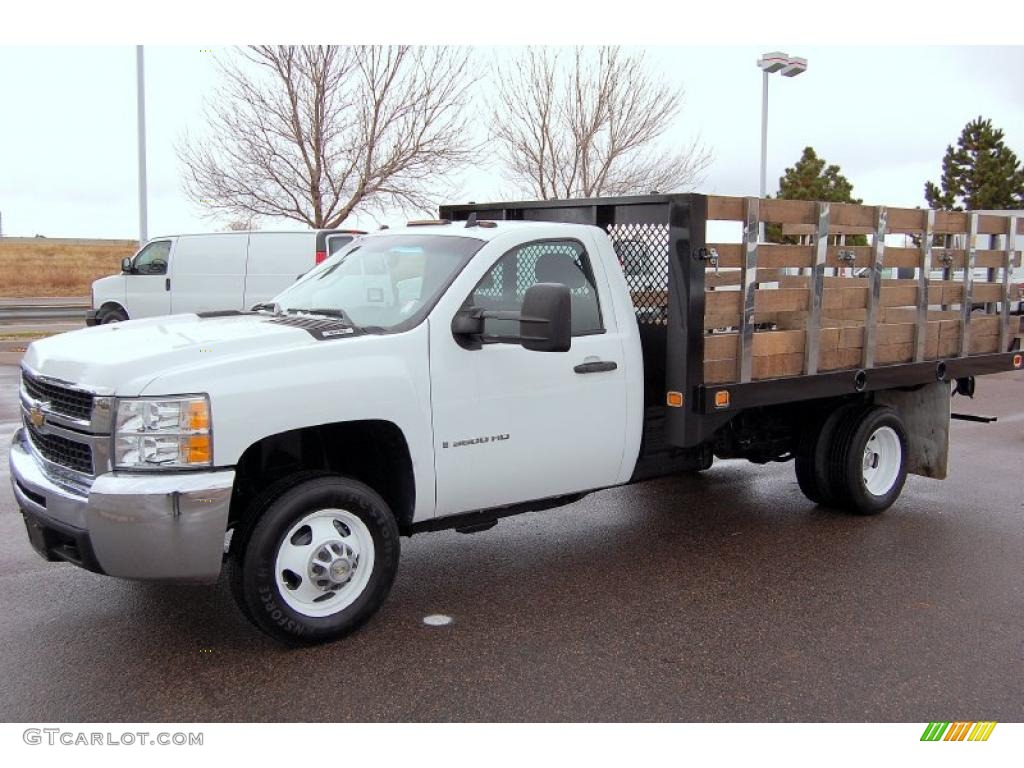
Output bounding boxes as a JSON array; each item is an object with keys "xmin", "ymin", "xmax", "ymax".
[{"xmin": 274, "ymin": 509, "xmax": 374, "ymax": 616}]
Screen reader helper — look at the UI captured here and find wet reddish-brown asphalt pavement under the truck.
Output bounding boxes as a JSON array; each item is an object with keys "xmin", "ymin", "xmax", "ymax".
[{"xmin": 0, "ymin": 367, "xmax": 1024, "ymax": 723}]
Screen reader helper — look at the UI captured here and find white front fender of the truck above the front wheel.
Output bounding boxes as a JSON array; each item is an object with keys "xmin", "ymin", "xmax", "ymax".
[{"xmin": 141, "ymin": 322, "xmax": 434, "ymax": 521}]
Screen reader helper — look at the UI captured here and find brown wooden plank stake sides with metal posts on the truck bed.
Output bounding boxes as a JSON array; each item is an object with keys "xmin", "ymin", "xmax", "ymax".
[{"xmin": 688, "ymin": 197, "xmax": 1024, "ymax": 385}]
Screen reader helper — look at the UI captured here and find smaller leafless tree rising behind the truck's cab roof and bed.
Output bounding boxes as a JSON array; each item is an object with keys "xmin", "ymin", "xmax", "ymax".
[{"xmin": 494, "ymin": 47, "xmax": 712, "ymax": 200}]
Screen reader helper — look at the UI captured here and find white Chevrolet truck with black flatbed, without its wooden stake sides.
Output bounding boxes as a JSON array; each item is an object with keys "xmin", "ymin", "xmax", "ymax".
[{"xmin": 10, "ymin": 196, "xmax": 1021, "ymax": 643}]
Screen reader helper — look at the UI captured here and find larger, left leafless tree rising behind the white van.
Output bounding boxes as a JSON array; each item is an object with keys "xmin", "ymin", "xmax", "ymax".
[{"xmin": 178, "ymin": 46, "xmax": 474, "ymax": 227}]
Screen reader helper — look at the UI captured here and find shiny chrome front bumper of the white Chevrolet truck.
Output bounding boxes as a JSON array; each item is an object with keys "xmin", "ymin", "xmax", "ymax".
[{"xmin": 9, "ymin": 429, "xmax": 234, "ymax": 582}]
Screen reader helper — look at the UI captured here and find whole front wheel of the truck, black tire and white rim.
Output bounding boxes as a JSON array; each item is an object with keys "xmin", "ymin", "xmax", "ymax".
[{"xmin": 228, "ymin": 474, "xmax": 400, "ymax": 645}]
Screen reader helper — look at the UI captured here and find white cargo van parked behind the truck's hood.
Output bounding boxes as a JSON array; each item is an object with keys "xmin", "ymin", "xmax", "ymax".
[{"xmin": 85, "ymin": 229, "xmax": 364, "ymax": 326}]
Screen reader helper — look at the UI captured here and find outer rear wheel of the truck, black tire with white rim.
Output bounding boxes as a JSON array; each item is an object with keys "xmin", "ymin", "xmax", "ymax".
[{"xmin": 828, "ymin": 406, "xmax": 906, "ymax": 515}]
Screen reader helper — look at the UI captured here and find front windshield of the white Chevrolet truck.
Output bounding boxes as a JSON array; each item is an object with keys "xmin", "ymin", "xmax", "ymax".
[{"xmin": 273, "ymin": 234, "xmax": 484, "ymax": 330}]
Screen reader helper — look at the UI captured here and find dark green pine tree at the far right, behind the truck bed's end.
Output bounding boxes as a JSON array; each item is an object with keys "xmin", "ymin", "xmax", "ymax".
[{"xmin": 925, "ymin": 117, "xmax": 1024, "ymax": 211}]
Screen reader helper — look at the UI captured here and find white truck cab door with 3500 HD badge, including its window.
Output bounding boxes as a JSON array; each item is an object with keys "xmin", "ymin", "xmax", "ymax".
[{"xmin": 430, "ymin": 229, "xmax": 628, "ymax": 516}]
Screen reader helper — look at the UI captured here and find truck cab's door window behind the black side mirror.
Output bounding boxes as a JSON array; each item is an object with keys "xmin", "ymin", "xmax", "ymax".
[{"xmin": 465, "ymin": 240, "xmax": 604, "ymax": 339}]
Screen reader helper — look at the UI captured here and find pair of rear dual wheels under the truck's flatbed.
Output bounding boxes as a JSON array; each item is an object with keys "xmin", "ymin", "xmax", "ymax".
[{"xmin": 796, "ymin": 403, "xmax": 907, "ymax": 515}]
